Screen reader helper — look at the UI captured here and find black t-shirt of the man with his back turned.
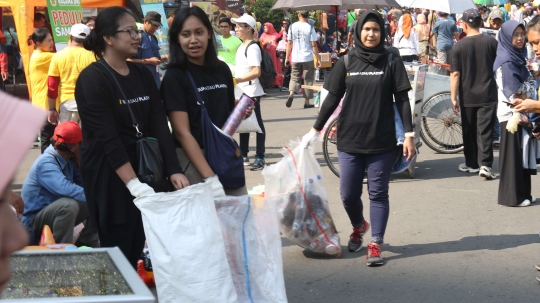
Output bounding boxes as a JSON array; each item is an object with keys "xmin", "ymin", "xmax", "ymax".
[{"xmin": 450, "ymin": 35, "xmax": 498, "ymax": 107}]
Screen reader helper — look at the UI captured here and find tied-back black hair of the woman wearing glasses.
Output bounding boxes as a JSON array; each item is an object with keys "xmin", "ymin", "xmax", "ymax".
[{"xmin": 83, "ymin": 6, "xmax": 131, "ymax": 58}]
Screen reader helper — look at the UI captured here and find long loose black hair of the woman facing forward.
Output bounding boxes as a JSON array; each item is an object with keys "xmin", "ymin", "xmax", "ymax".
[{"xmin": 167, "ymin": 6, "xmax": 220, "ymax": 69}]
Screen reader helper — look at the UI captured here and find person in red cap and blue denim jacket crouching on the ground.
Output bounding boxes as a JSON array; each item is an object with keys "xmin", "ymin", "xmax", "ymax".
[{"xmin": 22, "ymin": 121, "xmax": 99, "ymax": 247}]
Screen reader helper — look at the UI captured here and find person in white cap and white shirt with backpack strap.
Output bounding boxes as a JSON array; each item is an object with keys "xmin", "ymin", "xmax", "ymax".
[{"xmin": 231, "ymin": 15, "xmax": 266, "ymax": 170}]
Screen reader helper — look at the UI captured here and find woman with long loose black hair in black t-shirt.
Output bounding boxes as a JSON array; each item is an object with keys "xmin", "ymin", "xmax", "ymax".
[{"xmin": 161, "ymin": 6, "xmax": 251, "ymax": 197}]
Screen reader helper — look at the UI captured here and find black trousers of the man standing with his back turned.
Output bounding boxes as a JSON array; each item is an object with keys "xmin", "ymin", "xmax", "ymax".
[{"xmin": 461, "ymin": 103, "xmax": 497, "ymax": 168}]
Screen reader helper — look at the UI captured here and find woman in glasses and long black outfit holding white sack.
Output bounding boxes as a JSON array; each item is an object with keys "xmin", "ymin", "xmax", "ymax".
[{"xmin": 75, "ymin": 6, "xmax": 189, "ymax": 267}]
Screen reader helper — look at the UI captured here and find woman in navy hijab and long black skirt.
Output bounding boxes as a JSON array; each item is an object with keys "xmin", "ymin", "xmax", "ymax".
[{"xmin": 493, "ymin": 20, "xmax": 537, "ymax": 206}]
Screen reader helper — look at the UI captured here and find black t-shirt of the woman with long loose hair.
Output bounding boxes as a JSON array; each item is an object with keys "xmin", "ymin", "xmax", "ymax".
[{"xmin": 161, "ymin": 62, "xmax": 235, "ymax": 148}]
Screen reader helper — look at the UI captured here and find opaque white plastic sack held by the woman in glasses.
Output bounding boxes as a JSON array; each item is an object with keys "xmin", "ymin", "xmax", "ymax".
[{"xmin": 135, "ymin": 183, "xmax": 237, "ymax": 303}]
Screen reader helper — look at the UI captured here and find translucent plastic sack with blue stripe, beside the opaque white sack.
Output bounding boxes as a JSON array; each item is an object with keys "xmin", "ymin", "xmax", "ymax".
[{"xmin": 215, "ymin": 196, "xmax": 287, "ymax": 303}]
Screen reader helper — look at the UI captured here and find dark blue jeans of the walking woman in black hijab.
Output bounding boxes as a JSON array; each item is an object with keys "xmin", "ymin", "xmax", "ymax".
[{"xmin": 338, "ymin": 151, "xmax": 396, "ymax": 244}]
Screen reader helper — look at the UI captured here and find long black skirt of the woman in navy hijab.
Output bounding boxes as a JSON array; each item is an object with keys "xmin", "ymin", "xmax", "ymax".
[{"xmin": 498, "ymin": 122, "xmax": 536, "ymax": 206}]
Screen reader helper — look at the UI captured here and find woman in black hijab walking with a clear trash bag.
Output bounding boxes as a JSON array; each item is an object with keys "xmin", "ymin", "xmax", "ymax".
[{"xmin": 302, "ymin": 11, "xmax": 416, "ymax": 266}]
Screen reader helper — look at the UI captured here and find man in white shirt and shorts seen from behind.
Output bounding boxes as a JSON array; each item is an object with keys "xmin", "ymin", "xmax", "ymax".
[{"xmin": 285, "ymin": 11, "xmax": 321, "ymax": 108}]
